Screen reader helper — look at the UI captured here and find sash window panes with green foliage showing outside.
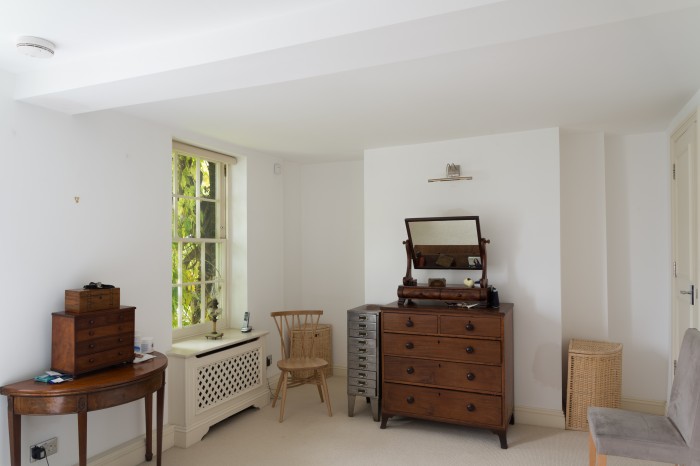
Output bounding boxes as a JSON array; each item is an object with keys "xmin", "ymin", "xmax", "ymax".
[{"xmin": 171, "ymin": 151, "xmax": 225, "ymax": 328}]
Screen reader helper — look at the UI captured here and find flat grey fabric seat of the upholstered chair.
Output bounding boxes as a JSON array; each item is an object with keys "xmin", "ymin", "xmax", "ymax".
[{"xmin": 588, "ymin": 407, "xmax": 690, "ymax": 464}]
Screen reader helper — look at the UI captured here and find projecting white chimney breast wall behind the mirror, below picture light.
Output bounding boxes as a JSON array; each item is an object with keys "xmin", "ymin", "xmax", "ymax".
[{"xmin": 364, "ymin": 128, "xmax": 561, "ymax": 412}]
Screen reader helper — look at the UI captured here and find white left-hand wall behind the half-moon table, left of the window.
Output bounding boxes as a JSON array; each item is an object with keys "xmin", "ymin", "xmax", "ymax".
[{"xmin": 0, "ymin": 72, "xmax": 171, "ymax": 466}]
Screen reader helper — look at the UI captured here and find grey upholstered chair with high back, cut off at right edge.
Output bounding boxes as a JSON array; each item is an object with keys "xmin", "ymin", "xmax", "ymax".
[{"xmin": 588, "ymin": 329, "xmax": 700, "ymax": 466}]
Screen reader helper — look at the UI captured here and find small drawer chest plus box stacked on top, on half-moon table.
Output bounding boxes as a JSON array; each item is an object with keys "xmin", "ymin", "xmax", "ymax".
[{"xmin": 51, "ymin": 288, "xmax": 136, "ymax": 376}]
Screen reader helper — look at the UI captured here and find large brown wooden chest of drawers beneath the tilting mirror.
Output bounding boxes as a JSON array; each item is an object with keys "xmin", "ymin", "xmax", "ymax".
[{"xmin": 381, "ymin": 301, "xmax": 514, "ymax": 448}]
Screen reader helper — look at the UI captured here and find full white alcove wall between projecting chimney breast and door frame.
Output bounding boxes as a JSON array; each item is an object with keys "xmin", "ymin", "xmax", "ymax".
[{"xmin": 561, "ymin": 131, "xmax": 671, "ymax": 403}]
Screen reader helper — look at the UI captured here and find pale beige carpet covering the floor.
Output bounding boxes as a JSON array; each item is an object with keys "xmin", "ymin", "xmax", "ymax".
[{"xmin": 142, "ymin": 376, "xmax": 661, "ymax": 466}]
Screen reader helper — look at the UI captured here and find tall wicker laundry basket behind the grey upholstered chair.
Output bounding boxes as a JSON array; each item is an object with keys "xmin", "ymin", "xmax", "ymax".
[{"xmin": 566, "ymin": 340, "xmax": 622, "ymax": 430}]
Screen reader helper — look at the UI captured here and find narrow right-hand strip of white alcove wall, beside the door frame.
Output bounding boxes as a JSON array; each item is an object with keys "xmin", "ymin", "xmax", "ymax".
[{"xmin": 605, "ymin": 133, "xmax": 671, "ymax": 400}]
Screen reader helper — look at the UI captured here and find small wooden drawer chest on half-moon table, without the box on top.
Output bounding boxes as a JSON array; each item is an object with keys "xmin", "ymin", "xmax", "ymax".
[{"xmin": 51, "ymin": 306, "xmax": 136, "ymax": 375}]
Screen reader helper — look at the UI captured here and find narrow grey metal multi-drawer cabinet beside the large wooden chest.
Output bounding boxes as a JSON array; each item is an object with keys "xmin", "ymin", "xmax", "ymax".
[{"xmin": 348, "ymin": 304, "xmax": 381, "ymax": 421}]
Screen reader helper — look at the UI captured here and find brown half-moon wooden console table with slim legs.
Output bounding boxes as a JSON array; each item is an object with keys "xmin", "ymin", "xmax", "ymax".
[{"xmin": 0, "ymin": 352, "xmax": 168, "ymax": 466}]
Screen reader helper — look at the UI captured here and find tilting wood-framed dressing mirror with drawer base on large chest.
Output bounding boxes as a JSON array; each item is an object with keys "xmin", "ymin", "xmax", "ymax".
[{"xmin": 397, "ymin": 216, "xmax": 490, "ymax": 304}]
